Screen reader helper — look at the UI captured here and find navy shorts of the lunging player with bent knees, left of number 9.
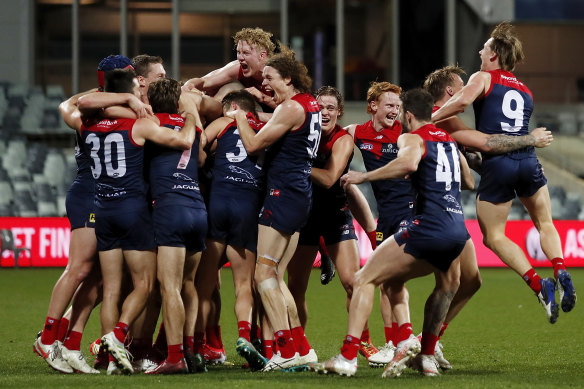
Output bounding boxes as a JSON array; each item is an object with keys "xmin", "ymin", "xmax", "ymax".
[{"xmin": 394, "ymin": 216, "xmax": 470, "ymax": 272}]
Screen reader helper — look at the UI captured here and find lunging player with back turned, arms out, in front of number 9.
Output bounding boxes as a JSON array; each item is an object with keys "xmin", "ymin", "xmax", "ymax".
[{"xmin": 314, "ymin": 89, "xmax": 474, "ymax": 377}]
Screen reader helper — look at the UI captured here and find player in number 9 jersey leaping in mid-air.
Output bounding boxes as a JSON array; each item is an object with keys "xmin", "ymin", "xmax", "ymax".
[{"xmin": 432, "ymin": 23, "xmax": 576, "ymax": 323}]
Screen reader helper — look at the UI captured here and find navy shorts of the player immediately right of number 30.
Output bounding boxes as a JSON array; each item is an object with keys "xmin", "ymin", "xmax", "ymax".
[{"xmin": 152, "ymin": 202, "xmax": 207, "ymax": 253}]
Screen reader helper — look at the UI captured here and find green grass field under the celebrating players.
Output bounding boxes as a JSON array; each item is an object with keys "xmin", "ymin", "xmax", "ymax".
[{"xmin": 0, "ymin": 269, "xmax": 584, "ymax": 389}]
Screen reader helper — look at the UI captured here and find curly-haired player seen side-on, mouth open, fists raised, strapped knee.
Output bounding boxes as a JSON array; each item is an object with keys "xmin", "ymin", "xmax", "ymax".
[{"xmin": 231, "ymin": 49, "xmax": 321, "ymax": 371}]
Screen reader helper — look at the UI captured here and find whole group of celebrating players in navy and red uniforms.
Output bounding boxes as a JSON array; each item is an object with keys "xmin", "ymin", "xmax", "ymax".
[{"xmin": 33, "ymin": 23, "xmax": 576, "ymax": 377}]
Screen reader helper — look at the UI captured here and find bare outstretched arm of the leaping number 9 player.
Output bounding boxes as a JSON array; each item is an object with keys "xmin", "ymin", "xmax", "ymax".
[{"xmin": 432, "ymin": 71, "xmax": 491, "ymax": 123}]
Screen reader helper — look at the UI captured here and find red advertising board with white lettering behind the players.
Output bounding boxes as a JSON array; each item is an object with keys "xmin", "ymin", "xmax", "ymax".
[{"xmin": 0, "ymin": 217, "xmax": 584, "ymax": 267}]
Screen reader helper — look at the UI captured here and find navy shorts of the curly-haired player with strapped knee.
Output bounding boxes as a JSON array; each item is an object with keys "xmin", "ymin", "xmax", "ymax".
[{"xmin": 259, "ymin": 188, "xmax": 312, "ymax": 235}]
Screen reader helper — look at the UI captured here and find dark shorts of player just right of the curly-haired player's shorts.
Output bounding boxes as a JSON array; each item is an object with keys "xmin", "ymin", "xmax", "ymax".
[{"xmin": 298, "ymin": 203, "xmax": 357, "ymax": 246}]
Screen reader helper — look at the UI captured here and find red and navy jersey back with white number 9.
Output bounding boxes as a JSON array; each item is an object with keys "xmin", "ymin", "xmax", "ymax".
[{"xmin": 473, "ymin": 69, "xmax": 533, "ymax": 136}]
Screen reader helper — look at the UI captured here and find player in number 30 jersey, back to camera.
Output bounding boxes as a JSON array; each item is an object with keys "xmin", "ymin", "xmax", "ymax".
[{"xmin": 79, "ymin": 70, "xmax": 200, "ymax": 374}]
